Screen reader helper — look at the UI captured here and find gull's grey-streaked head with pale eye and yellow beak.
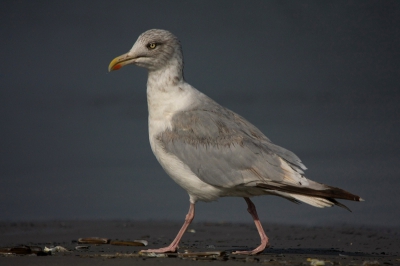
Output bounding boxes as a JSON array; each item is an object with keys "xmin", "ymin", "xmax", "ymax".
[{"xmin": 108, "ymin": 29, "xmax": 182, "ymax": 71}]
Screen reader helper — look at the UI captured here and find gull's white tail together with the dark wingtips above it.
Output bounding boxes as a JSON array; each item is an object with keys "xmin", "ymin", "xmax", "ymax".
[{"xmin": 256, "ymin": 180, "xmax": 364, "ymax": 212}]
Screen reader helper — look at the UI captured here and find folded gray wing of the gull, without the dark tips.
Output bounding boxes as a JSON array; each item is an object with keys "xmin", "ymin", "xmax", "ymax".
[{"xmin": 157, "ymin": 98, "xmax": 307, "ymax": 188}]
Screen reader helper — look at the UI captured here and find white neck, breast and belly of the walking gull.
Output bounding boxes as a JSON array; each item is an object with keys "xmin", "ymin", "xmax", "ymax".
[{"xmin": 147, "ymin": 58, "xmax": 221, "ymax": 203}]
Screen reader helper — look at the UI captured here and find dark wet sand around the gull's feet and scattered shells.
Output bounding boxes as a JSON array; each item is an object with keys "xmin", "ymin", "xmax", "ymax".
[{"xmin": 0, "ymin": 221, "xmax": 400, "ymax": 266}]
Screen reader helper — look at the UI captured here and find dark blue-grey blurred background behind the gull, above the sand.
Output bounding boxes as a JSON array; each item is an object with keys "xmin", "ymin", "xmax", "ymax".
[{"xmin": 0, "ymin": 0, "xmax": 400, "ymax": 226}]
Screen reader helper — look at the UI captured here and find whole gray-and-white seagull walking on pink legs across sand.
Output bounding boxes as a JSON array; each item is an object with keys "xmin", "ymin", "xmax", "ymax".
[{"xmin": 108, "ymin": 29, "xmax": 363, "ymax": 255}]
